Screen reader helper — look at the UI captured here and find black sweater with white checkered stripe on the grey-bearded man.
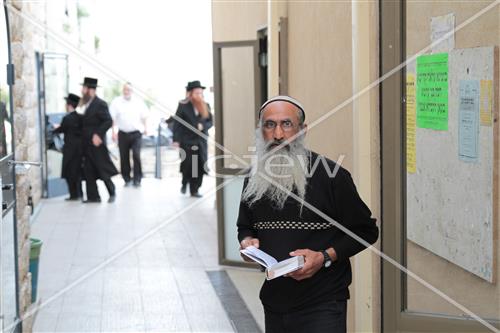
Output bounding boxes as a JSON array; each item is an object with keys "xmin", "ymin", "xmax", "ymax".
[{"xmin": 237, "ymin": 152, "xmax": 378, "ymax": 313}]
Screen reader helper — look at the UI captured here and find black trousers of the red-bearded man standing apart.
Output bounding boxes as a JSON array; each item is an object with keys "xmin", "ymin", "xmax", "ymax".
[{"xmin": 181, "ymin": 145, "xmax": 205, "ymax": 194}]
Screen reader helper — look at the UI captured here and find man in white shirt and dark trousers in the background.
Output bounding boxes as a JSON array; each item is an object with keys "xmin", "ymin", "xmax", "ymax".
[{"xmin": 110, "ymin": 82, "xmax": 149, "ymax": 187}]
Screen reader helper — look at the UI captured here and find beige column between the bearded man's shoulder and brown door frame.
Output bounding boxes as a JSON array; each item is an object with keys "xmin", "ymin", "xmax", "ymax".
[{"xmin": 352, "ymin": 1, "xmax": 379, "ymax": 332}]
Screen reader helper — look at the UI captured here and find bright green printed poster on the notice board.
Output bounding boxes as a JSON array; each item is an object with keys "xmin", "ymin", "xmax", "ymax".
[{"xmin": 417, "ymin": 53, "xmax": 448, "ymax": 131}]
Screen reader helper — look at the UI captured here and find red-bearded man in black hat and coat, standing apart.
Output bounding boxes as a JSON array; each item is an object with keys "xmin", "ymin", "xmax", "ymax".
[{"xmin": 173, "ymin": 81, "xmax": 213, "ymax": 198}]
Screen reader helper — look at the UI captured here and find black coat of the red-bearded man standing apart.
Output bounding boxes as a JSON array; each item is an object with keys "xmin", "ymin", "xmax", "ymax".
[{"xmin": 173, "ymin": 101, "xmax": 213, "ymax": 172}]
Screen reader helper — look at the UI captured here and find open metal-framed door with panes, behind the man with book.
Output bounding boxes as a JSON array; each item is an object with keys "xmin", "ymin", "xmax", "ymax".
[{"xmin": 213, "ymin": 40, "xmax": 265, "ymax": 266}]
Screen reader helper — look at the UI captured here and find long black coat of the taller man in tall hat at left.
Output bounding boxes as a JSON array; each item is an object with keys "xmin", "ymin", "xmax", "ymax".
[{"xmin": 83, "ymin": 96, "xmax": 118, "ymax": 180}]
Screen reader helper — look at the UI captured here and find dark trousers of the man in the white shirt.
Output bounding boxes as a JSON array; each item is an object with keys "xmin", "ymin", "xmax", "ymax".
[{"xmin": 118, "ymin": 131, "xmax": 142, "ymax": 183}]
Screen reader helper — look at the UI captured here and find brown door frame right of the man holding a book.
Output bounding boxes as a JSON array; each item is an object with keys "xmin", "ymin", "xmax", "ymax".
[{"xmin": 379, "ymin": 0, "xmax": 500, "ymax": 332}]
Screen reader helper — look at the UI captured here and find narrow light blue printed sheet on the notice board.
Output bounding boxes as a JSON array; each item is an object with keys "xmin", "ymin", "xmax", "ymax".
[{"xmin": 458, "ymin": 80, "xmax": 479, "ymax": 162}]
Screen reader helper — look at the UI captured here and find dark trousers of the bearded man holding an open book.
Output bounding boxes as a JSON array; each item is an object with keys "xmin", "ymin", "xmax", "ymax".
[{"xmin": 265, "ymin": 301, "xmax": 347, "ymax": 333}]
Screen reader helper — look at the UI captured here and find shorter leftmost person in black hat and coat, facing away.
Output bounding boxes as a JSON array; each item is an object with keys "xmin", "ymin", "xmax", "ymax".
[{"xmin": 54, "ymin": 94, "xmax": 83, "ymax": 201}]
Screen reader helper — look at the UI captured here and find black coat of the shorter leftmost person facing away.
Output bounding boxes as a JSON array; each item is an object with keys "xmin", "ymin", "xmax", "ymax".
[{"xmin": 54, "ymin": 111, "xmax": 83, "ymax": 180}]
